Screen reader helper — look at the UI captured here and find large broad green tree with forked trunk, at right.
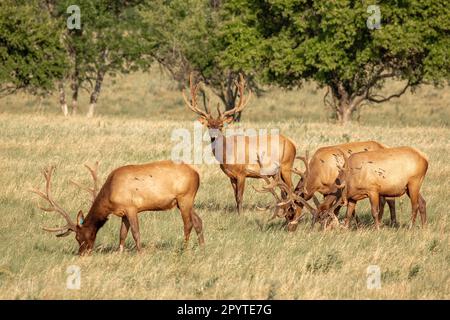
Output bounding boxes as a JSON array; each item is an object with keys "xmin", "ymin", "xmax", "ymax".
[{"xmin": 222, "ymin": 0, "xmax": 450, "ymax": 123}]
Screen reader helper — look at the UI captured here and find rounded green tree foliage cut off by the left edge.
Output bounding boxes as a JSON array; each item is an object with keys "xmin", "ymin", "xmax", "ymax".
[{"xmin": 0, "ymin": 0, "xmax": 66, "ymax": 97}]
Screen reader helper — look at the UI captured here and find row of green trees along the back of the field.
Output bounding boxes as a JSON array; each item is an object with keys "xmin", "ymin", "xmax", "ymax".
[{"xmin": 0, "ymin": 0, "xmax": 450, "ymax": 123}]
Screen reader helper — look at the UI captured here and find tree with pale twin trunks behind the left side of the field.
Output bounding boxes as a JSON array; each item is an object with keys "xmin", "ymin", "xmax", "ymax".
[{"xmin": 44, "ymin": 0, "xmax": 155, "ymax": 117}]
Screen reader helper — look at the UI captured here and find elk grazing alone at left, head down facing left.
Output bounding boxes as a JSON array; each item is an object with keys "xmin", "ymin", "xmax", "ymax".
[{"xmin": 31, "ymin": 161, "xmax": 204, "ymax": 255}]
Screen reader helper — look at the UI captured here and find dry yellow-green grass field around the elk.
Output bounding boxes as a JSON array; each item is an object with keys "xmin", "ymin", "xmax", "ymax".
[{"xmin": 0, "ymin": 73, "xmax": 450, "ymax": 299}]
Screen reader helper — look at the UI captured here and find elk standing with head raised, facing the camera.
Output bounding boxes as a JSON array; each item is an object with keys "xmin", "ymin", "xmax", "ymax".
[{"xmin": 183, "ymin": 75, "xmax": 296, "ymax": 213}]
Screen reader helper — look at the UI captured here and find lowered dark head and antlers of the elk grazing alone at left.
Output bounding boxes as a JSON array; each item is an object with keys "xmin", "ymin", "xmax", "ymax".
[{"xmin": 30, "ymin": 163, "xmax": 98, "ymax": 255}]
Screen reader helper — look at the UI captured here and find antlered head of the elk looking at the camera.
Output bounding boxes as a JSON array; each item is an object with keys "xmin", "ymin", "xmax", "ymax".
[{"xmin": 183, "ymin": 73, "xmax": 251, "ymax": 136}]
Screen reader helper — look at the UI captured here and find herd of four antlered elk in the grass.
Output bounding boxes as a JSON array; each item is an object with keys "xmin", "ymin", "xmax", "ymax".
[{"xmin": 31, "ymin": 75, "xmax": 428, "ymax": 255}]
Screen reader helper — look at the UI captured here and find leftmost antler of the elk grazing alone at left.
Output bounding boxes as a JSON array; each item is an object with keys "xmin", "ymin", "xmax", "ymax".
[{"xmin": 30, "ymin": 166, "xmax": 76, "ymax": 237}]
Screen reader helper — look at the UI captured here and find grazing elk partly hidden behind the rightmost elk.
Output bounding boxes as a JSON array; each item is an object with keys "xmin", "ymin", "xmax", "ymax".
[{"xmin": 294, "ymin": 141, "xmax": 397, "ymax": 225}]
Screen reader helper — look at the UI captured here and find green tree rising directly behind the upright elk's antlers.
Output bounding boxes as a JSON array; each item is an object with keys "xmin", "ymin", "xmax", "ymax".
[{"xmin": 145, "ymin": 0, "xmax": 259, "ymax": 120}]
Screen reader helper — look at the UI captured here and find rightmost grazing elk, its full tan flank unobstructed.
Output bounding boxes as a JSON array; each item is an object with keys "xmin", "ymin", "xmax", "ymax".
[{"xmin": 324, "ymin": 147, "xmax": 428, "ymax": 229}]
